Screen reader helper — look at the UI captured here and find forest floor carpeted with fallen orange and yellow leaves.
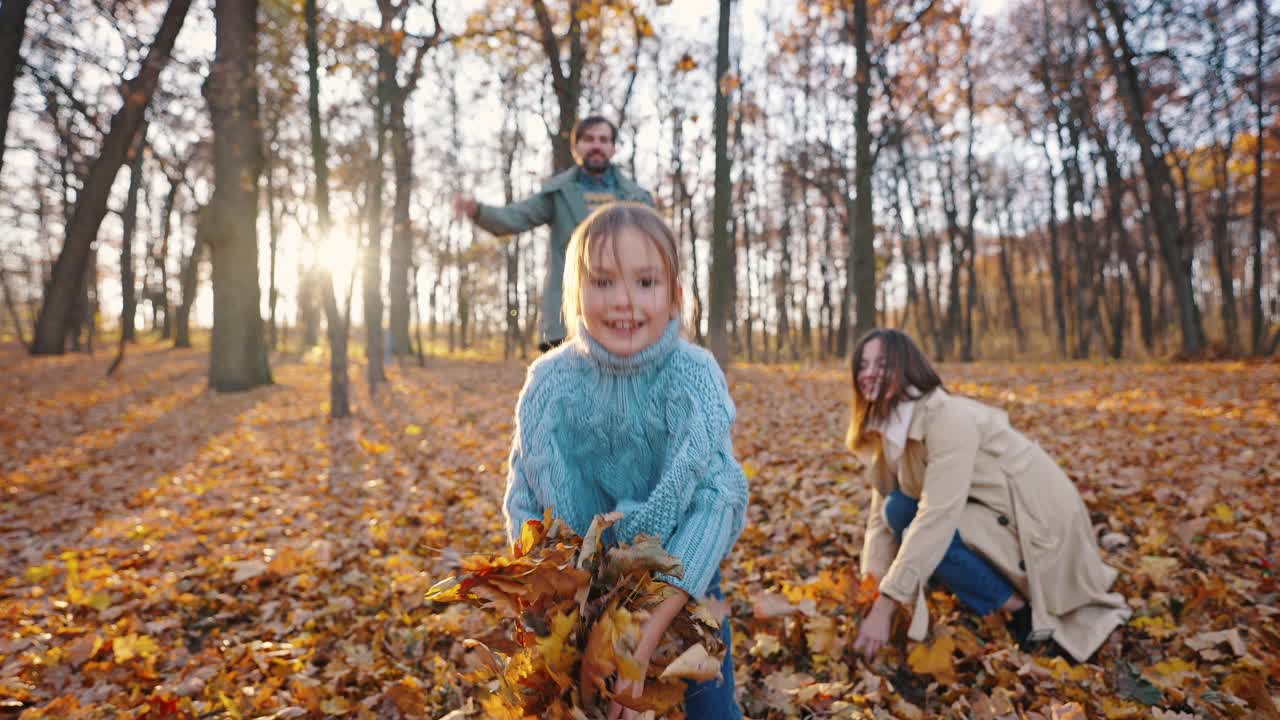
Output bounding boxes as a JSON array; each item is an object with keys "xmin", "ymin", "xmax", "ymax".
[{"xmin": 0, "ymin": 345, "xmax": 1280, "ymax": 720}]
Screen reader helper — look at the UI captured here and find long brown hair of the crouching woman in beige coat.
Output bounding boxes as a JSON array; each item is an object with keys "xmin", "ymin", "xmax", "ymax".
[{"xmin": 845, "ymin": 328, "xmax": 942, "ymax": 451}]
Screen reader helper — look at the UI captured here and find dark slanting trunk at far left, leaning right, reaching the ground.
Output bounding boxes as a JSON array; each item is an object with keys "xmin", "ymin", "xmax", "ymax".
[{"xmin": 30, "ymin": 0, "xmax": 192, "ymax": 355}]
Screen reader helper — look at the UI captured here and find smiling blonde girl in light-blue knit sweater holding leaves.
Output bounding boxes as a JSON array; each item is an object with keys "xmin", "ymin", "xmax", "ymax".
[{"xmin": 504, "ymin": 202, "xmax": 748, "ymax": 720}]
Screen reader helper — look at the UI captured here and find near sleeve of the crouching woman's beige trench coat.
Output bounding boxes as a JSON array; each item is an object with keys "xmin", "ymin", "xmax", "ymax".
[{"xmin": 879, "ymin": 402, "xmax": 979, "ymax": 603}]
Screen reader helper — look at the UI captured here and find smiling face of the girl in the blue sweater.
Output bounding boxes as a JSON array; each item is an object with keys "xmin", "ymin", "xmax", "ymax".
[{"xmin": 582, "ymin": 228, "xmax": 680, "ymax": 357}]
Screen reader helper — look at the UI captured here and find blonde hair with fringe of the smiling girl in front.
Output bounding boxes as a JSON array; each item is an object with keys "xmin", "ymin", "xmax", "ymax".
[{"xmin": 561, "ymin": 202, "xmax": 680, "ymax": 340}]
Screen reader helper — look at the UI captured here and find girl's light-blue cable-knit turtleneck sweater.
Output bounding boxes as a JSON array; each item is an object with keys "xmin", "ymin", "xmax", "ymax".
[{"xmin": 503, "ymin": 320, "xmax": 748, "ymax": 598}]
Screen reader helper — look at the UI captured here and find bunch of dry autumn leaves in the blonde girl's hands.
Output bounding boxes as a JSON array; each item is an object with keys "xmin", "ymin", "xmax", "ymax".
[{"xmin": 426, "ymin": 511, "xmax": 726, "ymax": 720}]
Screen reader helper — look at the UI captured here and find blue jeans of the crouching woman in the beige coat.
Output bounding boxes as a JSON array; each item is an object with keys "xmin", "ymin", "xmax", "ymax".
[{"xmin": 884, "ymin": 489, "xmax": 1014, "ymax": 615}]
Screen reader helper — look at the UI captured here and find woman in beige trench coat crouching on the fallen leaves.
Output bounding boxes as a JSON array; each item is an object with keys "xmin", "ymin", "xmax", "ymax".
[{"xmin": 846, "ymin": 329, "xmax": 1130, "ymax": 662}]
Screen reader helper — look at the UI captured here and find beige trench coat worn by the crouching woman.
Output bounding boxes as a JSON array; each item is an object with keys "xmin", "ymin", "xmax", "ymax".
[{"xmin": 861, "ymin": 388, "xmax": 1130, "ymax": 662}]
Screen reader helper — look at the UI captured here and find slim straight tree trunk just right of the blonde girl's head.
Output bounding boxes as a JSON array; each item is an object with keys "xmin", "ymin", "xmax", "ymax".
[{"xmin": 707, "ymin": 0, "xmax": 736, "ymax": 368}]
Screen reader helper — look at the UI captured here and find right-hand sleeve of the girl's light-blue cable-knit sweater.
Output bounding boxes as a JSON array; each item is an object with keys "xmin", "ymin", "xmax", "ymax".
[{"xmin": 618, "ymin": 355, "xmax": 748, "ymax": 597}]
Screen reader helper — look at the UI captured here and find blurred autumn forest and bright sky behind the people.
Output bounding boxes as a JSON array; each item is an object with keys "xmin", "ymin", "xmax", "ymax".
[{"xmin": 0, "ymin": 0, "xmax": 1280, "ymax": 389}]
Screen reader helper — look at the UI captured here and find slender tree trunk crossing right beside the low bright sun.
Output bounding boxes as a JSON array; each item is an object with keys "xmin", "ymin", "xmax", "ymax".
[{"xmin": 303, "ymin": 0, "xmax": 351, "ymax": 419}]
